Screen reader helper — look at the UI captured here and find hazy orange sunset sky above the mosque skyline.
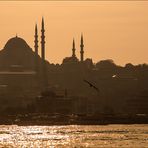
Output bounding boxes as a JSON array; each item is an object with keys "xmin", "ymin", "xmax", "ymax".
[{"xmin": 0, "ymin": 1, "xmax": 148, "ymax": 65}]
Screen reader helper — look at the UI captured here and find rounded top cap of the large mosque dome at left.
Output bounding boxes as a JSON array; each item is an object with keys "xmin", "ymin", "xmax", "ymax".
[{"xmin": 4, "ymin": 36, "xmax": 30, "ymax": 50}]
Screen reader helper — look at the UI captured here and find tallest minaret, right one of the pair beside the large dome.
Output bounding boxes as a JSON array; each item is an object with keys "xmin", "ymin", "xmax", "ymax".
[{"xmin": 41, "ymin": 17, "xmax": 45, "ymax": 60}]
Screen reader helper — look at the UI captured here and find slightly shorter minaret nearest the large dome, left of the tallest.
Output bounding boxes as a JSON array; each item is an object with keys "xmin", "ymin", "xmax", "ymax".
[{"xmin": 34, "ymin": 24, "xmax": 38, "ymax": 72}]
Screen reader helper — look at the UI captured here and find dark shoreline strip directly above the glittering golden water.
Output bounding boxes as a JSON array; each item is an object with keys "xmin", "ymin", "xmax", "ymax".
[{"xmin": 0, "ymin": 115, "xmax": 148, "ymax": 126}]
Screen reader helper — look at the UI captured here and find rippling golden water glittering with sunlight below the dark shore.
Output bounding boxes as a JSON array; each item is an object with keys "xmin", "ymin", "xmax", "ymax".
[{"xmin": 0, "ymin": 125, "xmax": 148, "ymax": 148}]
